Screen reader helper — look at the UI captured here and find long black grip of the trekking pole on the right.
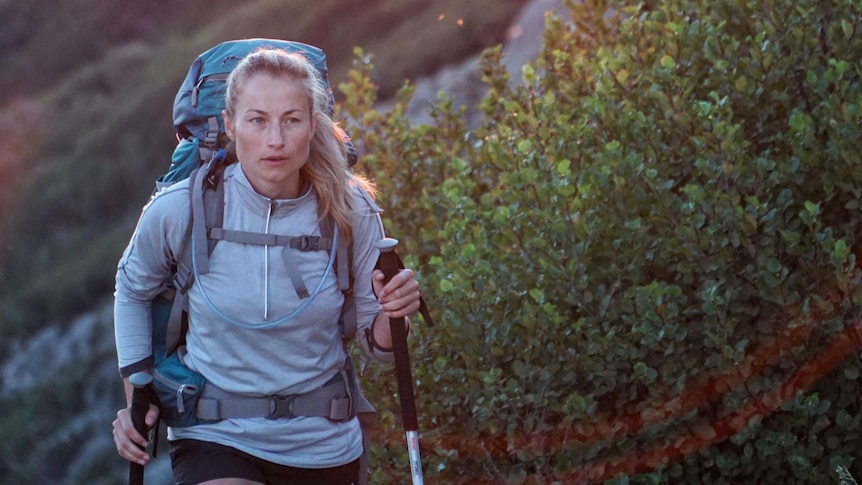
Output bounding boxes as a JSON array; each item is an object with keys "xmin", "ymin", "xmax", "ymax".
[{"xmin": 377, "ymin": 238, "xmax": 419, "ymax": 431}]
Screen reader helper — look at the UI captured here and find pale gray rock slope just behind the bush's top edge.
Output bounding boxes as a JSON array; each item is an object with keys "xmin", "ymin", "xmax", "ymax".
[{"xmin": 390, "ymin": 0, "xmax": 566, "ymax": 126}]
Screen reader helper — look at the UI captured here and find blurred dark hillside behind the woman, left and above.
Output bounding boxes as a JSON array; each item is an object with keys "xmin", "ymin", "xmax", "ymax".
[{"xmin": 0, "ymin": 0, "xmax": 528, "ymax": 483}]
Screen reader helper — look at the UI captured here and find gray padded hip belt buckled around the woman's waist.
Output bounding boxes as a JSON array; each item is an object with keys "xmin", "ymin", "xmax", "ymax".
[{"xmin": 197, "ymin": 364, "xmax": 356, "ymax": 421}]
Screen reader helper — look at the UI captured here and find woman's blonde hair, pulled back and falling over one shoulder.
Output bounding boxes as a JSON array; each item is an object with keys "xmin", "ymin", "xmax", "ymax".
[{"xmin": 225, "ymin": 48, "xmax": 374, "ymax": 241}]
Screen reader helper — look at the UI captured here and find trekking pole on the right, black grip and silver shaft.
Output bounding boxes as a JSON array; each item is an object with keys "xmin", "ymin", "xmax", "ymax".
[{"xmin": 377, "ymin": 238, "xmax": 424, "ymax": 485}]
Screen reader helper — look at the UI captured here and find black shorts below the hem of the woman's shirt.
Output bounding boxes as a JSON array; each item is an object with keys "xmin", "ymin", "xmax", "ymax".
[{"xmin": 171, "ymin": 440, "xmax": 359, "ymax": 485}]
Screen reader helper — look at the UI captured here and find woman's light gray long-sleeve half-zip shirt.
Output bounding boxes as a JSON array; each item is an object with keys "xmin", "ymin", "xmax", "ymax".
[{"xmin": 115, "ymin": 164, "xmax": 392, "ymax": 468}]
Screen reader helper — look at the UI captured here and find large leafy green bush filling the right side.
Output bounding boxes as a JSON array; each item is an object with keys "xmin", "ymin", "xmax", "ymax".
[{"xmin": 341, "ymin": 0, "xmax": 862, "ymax": 484}]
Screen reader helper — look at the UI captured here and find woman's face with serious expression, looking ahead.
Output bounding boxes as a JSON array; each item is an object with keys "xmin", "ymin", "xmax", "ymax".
[{"xmin": 223, "ymin": 73, "xmax": 315, "ymax": 199}]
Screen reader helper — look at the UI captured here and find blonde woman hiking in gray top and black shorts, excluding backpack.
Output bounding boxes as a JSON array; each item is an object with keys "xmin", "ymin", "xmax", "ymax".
[{"xmin": 114, "ymin": 49, "xmax": 419, "ymax": 485}]
